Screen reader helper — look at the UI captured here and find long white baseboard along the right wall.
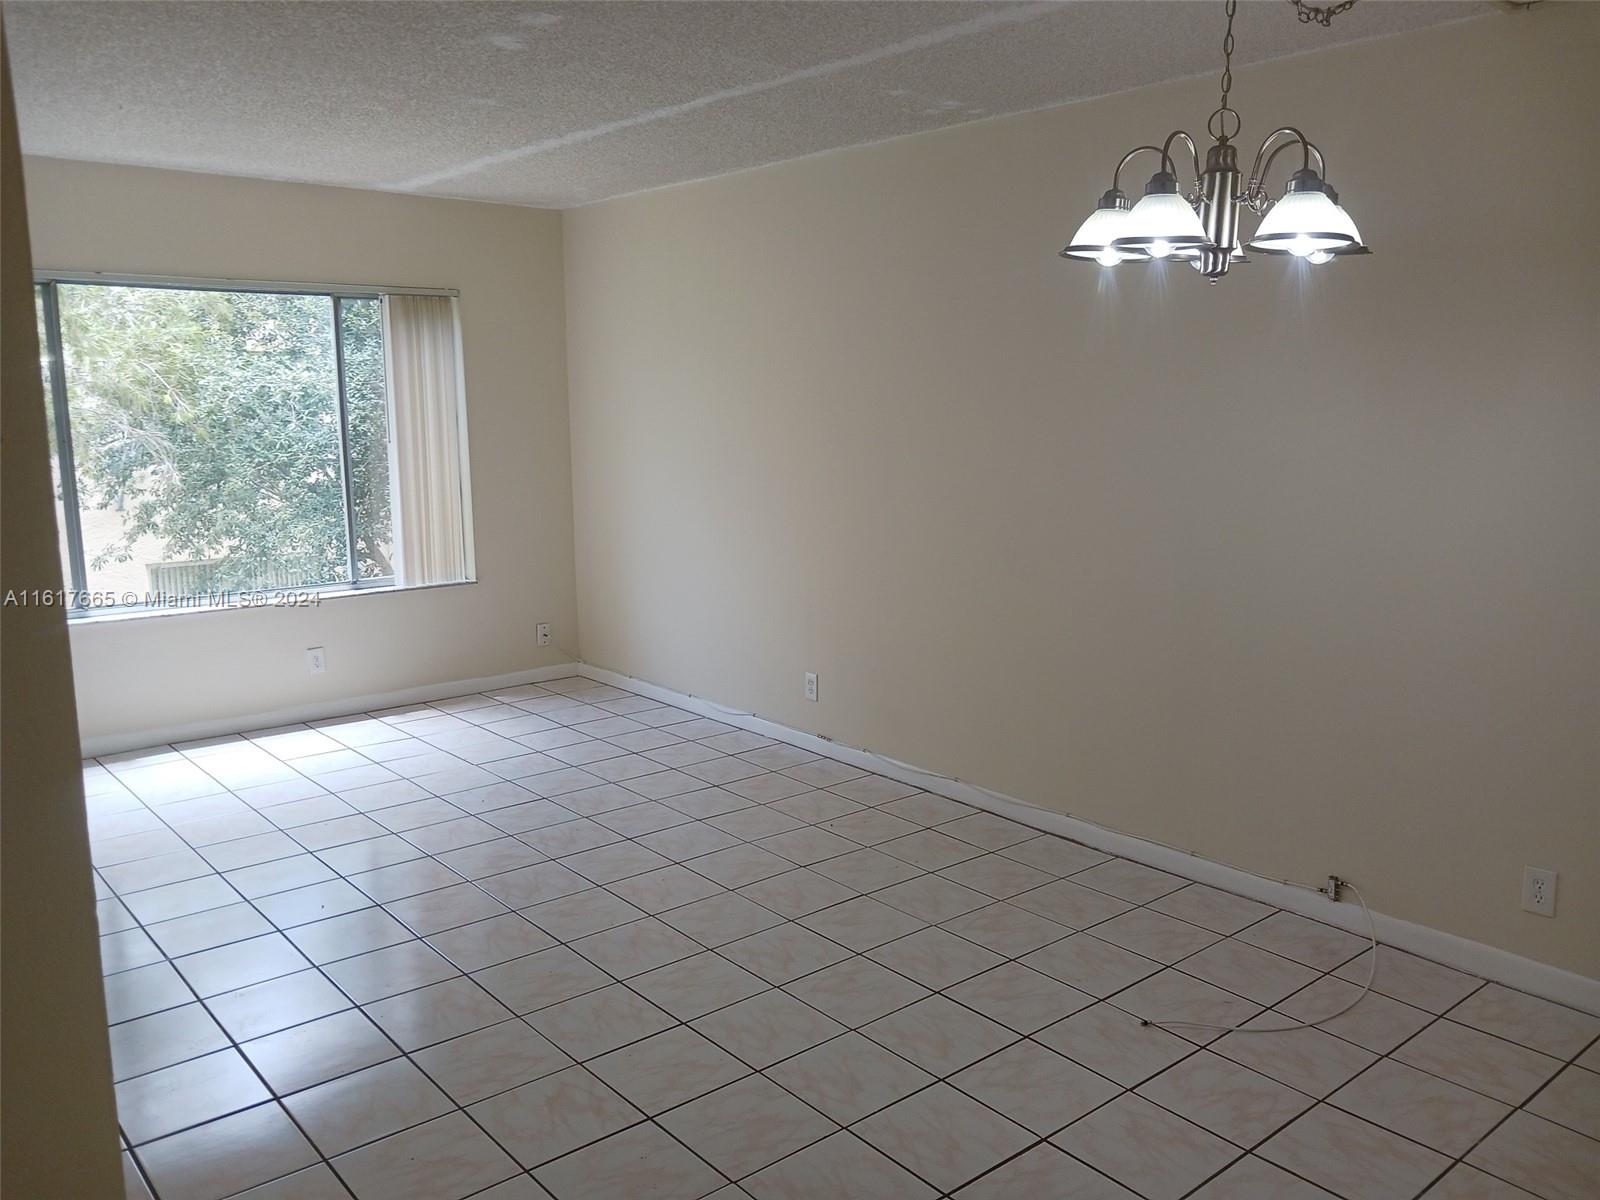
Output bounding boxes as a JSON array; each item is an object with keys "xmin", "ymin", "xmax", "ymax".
[{"xmin": 582, "ymin": 664, "xmax": 1600, "ymax": 1014}]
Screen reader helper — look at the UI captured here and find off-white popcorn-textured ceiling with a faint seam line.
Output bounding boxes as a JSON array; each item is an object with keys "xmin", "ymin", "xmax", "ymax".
[{"xmin": 5, "ymin": 0, "xmax": 1485, "ymax": 206}]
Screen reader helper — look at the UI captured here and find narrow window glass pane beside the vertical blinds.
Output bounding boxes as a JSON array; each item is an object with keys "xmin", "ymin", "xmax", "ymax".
[{"xmin": 339, "ymin": 296, "xmax": 395, "ymax": 579}]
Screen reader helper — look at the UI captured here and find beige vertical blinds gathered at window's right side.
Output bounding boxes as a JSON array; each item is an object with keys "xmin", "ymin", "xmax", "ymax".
[{"xmin": 384, "ymin": 294, "xmax": 472, "ymax": 586}]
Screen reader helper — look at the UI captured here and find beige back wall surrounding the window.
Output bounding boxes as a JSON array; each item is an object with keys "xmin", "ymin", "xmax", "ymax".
[{"xmin": 27, "ymin": 158, "xmax": 578, "ymax": 739}]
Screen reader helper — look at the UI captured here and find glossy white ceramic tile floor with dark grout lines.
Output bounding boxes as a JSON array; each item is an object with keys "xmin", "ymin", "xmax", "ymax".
[{"xmin": 85, "ymin": 678, "xmax": 1600, "ymax": 1200}]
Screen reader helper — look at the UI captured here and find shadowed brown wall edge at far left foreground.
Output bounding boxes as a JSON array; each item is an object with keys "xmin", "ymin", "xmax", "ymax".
[{"xmin": 0, "ymin": 23, "xmax": 122, "ymax": 1200}]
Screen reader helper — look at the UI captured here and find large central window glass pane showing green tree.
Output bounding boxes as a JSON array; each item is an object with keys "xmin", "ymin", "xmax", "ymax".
[{"xmin": 58, "ymin": 283, "xmax": 349, "ymax": 597}]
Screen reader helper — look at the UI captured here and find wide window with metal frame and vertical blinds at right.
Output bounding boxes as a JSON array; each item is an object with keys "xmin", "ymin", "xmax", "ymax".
[{"xmin": 38, "ymin": 278, "xmax": 470, "ymax": 614}]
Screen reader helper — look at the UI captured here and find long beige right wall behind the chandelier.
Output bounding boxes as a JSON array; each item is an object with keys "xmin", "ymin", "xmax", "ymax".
[{"xmin": 566, "ymin": 5, "xmax": 1600, "ymax": 974}]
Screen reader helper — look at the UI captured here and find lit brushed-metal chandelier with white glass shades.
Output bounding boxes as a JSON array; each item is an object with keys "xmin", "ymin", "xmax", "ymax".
[{"xmin": 1061, "ymin": 0, "xmax": 1371, "ymax": 283}]
